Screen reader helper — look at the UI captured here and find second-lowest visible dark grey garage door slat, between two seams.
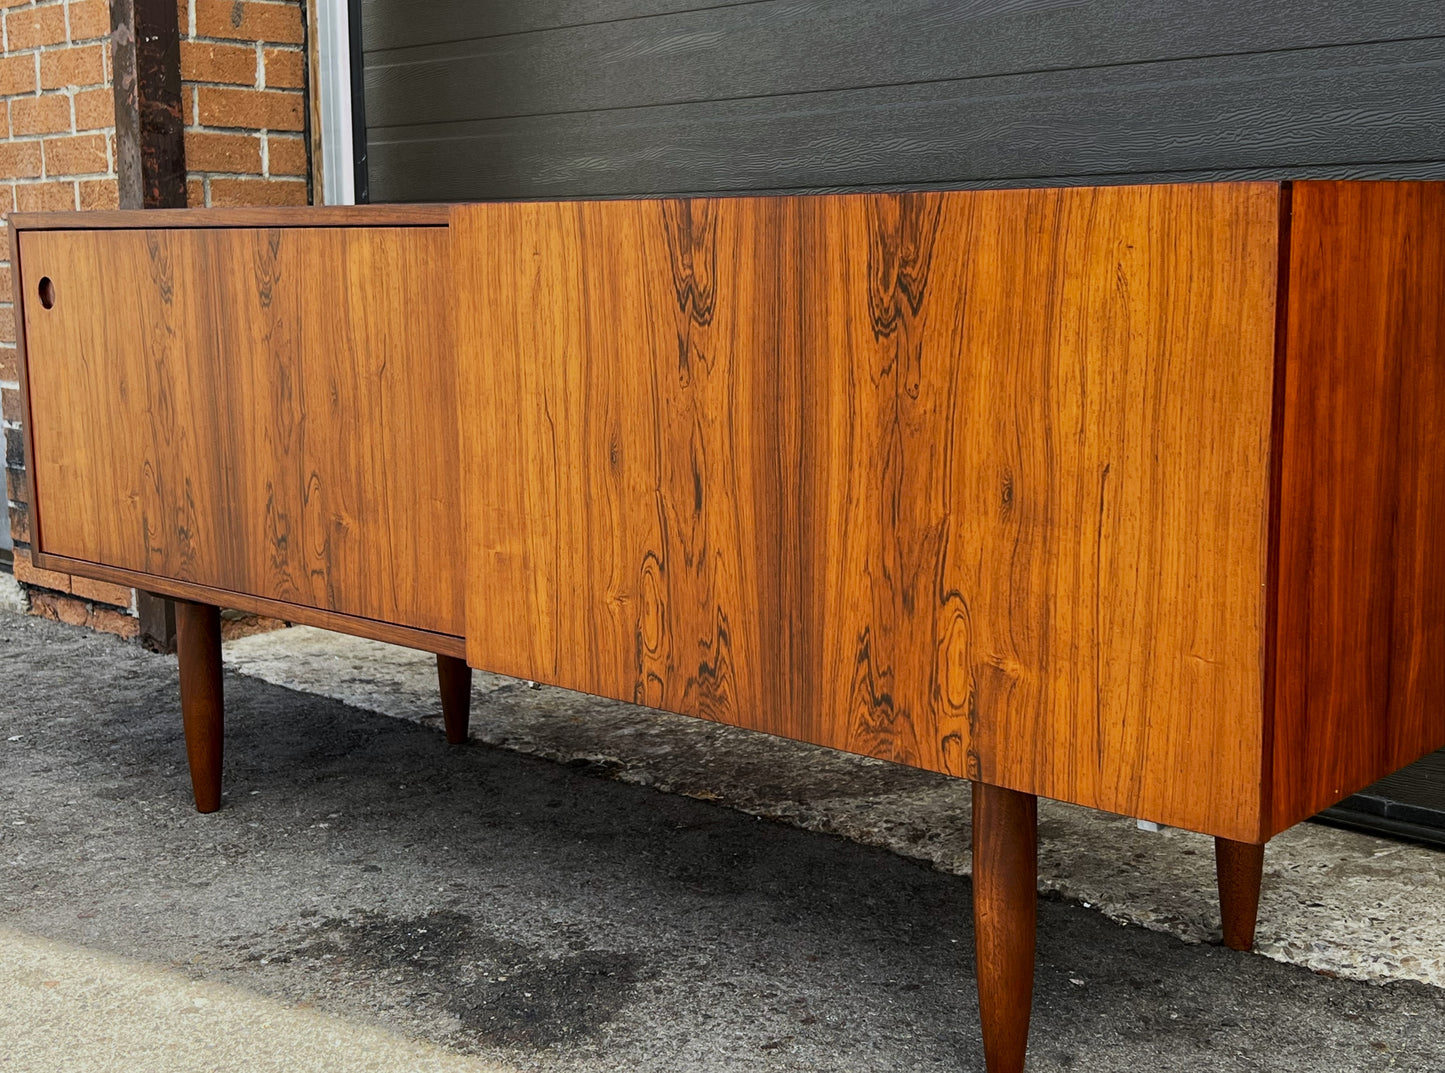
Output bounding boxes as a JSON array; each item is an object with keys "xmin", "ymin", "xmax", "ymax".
[{"xmin": 366, "ymin": 0, "xmax": 1445, "ymax": 129}]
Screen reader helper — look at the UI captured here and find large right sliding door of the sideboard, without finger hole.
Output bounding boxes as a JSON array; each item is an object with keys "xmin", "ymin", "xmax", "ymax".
[{"xmin": 452, "ymin": 185, "xmax": 1280, "ymax": 838}]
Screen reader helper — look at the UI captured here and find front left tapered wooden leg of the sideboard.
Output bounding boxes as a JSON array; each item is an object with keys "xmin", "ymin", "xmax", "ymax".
[{"xmin": 176, "ymin": 599, "xmax": 224, "ymax": 812}]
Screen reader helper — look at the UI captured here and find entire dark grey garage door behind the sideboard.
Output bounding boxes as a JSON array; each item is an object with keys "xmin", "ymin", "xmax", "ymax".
[{"xmin": 354, "ymin": 0, "xmax": 1445, "ymax": 838}]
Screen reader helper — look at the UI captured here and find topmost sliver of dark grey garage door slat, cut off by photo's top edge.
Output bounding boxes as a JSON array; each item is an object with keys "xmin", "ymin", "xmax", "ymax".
[{"xmin": 361, "ymin": 0, "xmax": 757, "ymax": 49}]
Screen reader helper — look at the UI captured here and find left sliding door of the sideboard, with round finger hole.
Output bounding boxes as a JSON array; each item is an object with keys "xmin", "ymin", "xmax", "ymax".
[{"xmin": 20, "ymin": 225, "xmax": 462, "ymax": 635}]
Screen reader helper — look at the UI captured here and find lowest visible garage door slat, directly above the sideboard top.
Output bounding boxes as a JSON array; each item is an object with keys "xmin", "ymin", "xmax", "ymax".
[{"xmin": 370, "ymin": 39, "xmax": 1445, "ymax": 201}]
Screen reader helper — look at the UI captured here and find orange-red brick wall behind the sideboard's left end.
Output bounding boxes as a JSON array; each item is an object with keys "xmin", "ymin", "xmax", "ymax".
[{"xmin": 0, "ymin": 0, "xmax": 311, "ymax": 637}]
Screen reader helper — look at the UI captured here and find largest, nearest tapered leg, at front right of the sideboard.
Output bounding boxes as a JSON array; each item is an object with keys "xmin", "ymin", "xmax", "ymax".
[{"xmin": 974, "ymin": 783, "xmax": 1039, "ymax": 1073}]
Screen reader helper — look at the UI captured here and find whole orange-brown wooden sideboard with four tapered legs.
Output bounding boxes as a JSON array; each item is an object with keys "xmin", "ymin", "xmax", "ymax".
[{"xmin": 12, "ymin": 182, "xmax": 1445, "ymax": 1073}]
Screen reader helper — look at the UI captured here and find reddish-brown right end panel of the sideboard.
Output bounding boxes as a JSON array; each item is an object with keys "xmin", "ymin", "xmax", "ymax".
[{"xmin": 1270, "ymin": 182, "xmax": 1445, "ymax": 830}]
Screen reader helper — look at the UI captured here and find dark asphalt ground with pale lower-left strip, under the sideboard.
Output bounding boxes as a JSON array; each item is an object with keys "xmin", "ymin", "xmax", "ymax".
[{"xmin": 0, "ymin": 612, "xmax": 1445, "ymax": 1073}]
